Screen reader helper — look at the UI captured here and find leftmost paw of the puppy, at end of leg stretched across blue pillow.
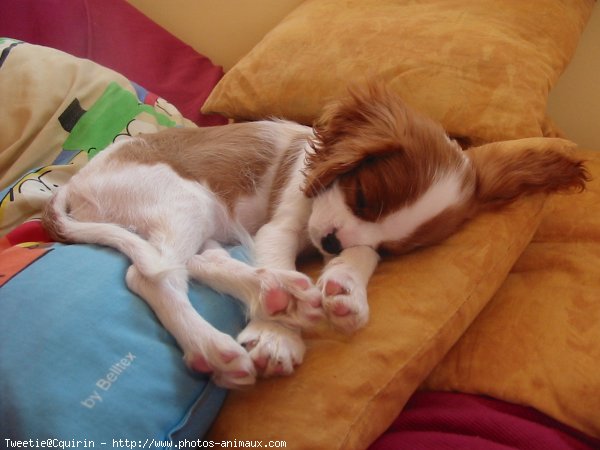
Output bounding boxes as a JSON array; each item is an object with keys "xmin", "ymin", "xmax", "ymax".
[{"xmin": 183, "ymin": 332, "xmax": 256, "ymax": 389}]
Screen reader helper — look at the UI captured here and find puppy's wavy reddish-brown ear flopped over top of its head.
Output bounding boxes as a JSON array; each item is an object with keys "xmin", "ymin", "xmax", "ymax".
[{"xmin": 304, "ymin": 82, "xmax": 408, "ymax": 197}]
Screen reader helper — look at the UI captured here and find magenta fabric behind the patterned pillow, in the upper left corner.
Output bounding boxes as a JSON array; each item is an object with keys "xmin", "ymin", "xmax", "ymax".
[{"xmin": 0, "ymin": 0, "xmax": 227, "ymax": 126}]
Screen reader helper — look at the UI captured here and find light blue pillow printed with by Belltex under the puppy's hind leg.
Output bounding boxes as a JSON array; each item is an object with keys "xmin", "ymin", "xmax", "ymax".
[{"xmin": 0, "ymin": 244, "xmax": 245, "ymax": 442}]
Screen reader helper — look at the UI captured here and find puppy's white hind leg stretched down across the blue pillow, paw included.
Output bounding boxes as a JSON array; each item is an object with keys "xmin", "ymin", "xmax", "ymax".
[{"xmin": 126, "ymin": 266, "xmax": 255, "ymax": 388}]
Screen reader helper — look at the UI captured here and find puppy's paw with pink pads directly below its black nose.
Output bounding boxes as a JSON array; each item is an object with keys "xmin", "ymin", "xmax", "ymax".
[{"xmin": 317, "ymin": 265, "xmax": 369, "ymax": 333}]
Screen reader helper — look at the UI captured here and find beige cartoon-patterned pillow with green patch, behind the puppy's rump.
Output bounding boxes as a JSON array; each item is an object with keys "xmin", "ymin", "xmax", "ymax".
[{"xmin": 0, "ymin": 38, "xmax": 195, "ymax": 283}]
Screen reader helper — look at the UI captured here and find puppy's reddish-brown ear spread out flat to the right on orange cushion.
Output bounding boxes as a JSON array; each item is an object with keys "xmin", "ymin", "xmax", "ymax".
[{"xmin": 466, "ymin": 138, "xmax": 590, "ymax": 209}]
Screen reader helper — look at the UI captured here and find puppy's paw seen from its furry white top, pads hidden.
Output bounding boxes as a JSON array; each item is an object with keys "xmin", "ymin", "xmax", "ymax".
[{"xmin": 237, "ymin": 319, "xmax": 306, "ymax": 377}]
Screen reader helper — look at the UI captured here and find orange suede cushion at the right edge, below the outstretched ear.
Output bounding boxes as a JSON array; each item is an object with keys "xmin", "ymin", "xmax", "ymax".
[{"xmin": 424, "ymin": 152, "xmax": 600, "ymax": 437}]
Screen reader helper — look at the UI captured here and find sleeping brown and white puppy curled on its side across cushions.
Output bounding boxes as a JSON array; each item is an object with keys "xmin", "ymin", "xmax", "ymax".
[{"xmin": 44, "ymin": 84, "xmax": 587, "ymax": 387}]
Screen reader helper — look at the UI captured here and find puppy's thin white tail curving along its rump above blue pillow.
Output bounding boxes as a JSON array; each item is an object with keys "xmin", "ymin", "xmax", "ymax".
[{"xmin": 42, "ymin": 186, "xmax": 180, "ymax": 278}]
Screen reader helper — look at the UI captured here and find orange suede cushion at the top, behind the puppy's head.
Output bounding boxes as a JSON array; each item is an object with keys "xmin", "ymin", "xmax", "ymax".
[{"xmin": 203, "ymin": 0, "xmax": 594, "ymax": 142}]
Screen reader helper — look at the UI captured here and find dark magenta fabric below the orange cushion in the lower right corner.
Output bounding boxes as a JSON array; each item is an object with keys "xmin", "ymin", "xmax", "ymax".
[{"xmin": 369, "ymin": 392, "xmax": 600, "ymax": 450}]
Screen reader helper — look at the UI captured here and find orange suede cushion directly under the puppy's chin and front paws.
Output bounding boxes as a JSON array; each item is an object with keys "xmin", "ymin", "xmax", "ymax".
[{"xmin": 209, "ymin": 138, "xmax": 566, "ymax": 450}]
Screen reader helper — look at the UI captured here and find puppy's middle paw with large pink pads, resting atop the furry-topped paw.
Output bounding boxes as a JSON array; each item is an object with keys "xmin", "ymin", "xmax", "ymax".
[{"xmin": 253, "ymin": 269, "xmax": 324, "ymax": 328}]
